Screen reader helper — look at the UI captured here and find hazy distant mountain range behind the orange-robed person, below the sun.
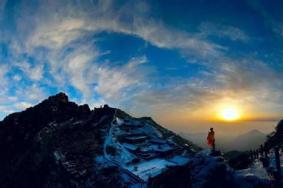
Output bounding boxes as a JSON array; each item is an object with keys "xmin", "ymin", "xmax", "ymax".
[{"xmin": 180, "ymin": 130, "xmax": 267, "ymax": 152}]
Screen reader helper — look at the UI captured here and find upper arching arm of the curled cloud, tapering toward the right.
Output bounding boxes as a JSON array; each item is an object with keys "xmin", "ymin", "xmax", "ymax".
[{"xmin": 22, "ymin": 1, "xmax": 224, "ymax": 57}]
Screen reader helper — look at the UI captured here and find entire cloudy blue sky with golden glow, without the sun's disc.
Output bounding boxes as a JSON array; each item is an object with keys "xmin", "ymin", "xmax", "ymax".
[{"xmin": 0, "ymin": 0, "xmax": 283, "ymax": 133}]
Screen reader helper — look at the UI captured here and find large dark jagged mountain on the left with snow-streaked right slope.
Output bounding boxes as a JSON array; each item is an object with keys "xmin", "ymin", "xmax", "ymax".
[{"xmin": 0, "ymin": 93, "xmax": 199, "ymax": 188}]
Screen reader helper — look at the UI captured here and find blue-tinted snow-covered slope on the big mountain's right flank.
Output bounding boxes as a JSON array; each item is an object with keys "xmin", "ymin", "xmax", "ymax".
[{"xmin": 101, "ymin": 111, "xmax": 196, "ymax": 181}]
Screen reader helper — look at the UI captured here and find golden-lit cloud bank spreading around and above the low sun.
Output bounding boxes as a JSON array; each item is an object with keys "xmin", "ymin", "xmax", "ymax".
[{"xmin": 125, "ymin": 57, "xmax": 283, "ymax": 121}]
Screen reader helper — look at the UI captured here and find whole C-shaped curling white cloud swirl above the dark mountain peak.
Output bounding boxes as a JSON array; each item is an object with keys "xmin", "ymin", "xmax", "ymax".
[{"xmin": 10, "ymin": 1, "xmax": 224, "ymax": 106}]
